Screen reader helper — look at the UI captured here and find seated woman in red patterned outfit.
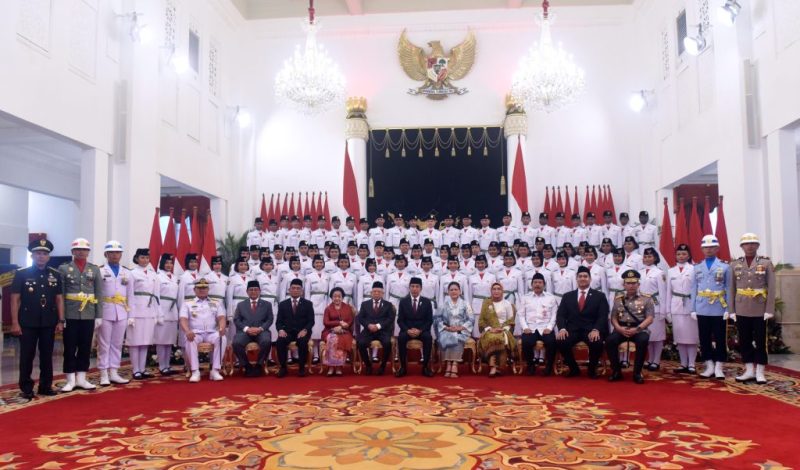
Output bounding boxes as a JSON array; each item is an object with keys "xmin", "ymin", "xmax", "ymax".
[{"xmin": 322, "ymin": 287, "xmax": 356, "ymax": 377}]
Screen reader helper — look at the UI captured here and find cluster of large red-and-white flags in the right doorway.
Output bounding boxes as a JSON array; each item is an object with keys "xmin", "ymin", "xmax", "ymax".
[{"xmin": 658, "ymin": 196, "xmax": 731, "ymax": 266}]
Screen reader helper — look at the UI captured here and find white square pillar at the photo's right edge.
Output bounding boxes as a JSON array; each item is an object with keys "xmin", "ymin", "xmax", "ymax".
[{"xmin": 764, "ymin": 129, "xmax": 800, "ymax": 264}]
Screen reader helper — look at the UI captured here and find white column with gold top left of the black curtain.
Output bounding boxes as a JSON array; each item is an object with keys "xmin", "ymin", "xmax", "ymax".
[{"xmin": 342, "ymin": 97, "xmax": 369, "ymax": 220}]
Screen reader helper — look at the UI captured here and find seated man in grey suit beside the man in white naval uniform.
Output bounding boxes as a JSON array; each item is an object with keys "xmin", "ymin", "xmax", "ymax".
[{"xmin": 233, "ymin": 281, "xmax": 272, "ymax": 377}]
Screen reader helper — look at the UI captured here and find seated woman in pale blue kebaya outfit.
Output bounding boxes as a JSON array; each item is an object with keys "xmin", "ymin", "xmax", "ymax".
[{"xmin": 433, "ymin": 282, "xmax": 475, "ymax": 378}]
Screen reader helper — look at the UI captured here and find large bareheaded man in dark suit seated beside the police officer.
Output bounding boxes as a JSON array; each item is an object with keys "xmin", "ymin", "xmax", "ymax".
[{"xmin": 556, "ymin": 266, "xmax": 608, "ymax": 379}]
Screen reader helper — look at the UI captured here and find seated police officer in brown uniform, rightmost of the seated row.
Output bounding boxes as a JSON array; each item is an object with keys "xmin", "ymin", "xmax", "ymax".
[{"xmin": 606, "ymin": 269, "xmax": 655, "ymax": 383}]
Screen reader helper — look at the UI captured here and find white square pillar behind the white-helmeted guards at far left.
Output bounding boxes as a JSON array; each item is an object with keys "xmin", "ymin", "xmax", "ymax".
[{"xmin": 78, "ymin": 149, "xmax": 109, "ymax": 264}]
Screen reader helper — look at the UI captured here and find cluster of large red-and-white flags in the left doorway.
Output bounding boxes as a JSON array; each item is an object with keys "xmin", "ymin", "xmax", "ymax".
[{"xmin": 150, "ymin": 207, "xmax": 217, "ymax": 274}]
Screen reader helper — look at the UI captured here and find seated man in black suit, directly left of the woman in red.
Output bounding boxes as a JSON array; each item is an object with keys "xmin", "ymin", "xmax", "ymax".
[{"xmin": 275, "ymin": 279, "xmax": 314, "ymax": 378}]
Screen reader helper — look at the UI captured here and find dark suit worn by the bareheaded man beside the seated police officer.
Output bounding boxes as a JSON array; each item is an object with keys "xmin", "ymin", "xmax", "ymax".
[{"xmin": 556, "ymin": 289, "xmax": 608, "ymax": 375}]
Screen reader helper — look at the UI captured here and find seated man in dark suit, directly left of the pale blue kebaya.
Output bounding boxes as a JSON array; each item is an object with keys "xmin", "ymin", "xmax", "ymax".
[{"xmin": 394, "ymin": 277, "xmax": 433, "ymax": 377}]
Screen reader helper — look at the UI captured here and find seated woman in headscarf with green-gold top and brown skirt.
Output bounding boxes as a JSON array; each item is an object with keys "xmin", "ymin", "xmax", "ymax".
[{"xmin": 478, "ymin": 282, "xmax": 517, "ymax": 378}]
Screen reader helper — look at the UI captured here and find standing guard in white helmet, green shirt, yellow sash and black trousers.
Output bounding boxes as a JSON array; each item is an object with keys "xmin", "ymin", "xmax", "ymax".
[{"xmin": 58, "ymin": 238, "xmax": 103, "ymax": 392}]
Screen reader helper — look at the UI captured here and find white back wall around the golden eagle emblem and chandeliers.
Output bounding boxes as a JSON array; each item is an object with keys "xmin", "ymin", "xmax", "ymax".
[{"xmin": 242, "ymin": 7, "xmax": 639, "ymax": 222}]
